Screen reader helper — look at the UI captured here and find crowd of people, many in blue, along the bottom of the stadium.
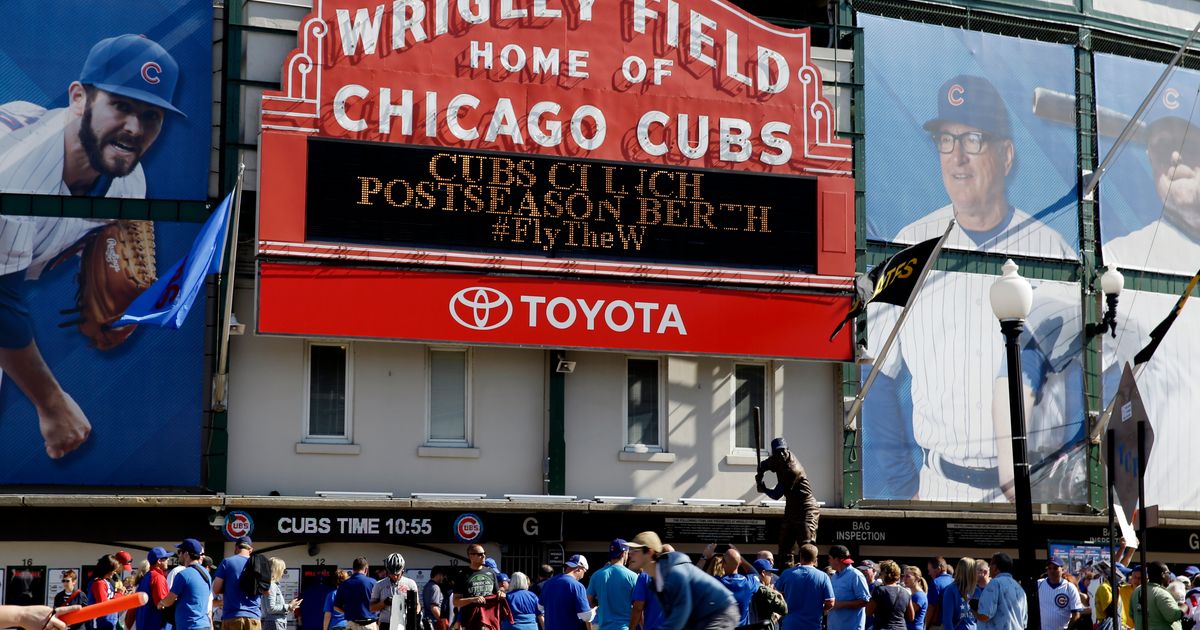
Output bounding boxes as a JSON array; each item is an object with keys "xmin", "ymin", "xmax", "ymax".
[{"xmin": 14, "ymin": 532, "xmax": 1200, "ymax": 630}]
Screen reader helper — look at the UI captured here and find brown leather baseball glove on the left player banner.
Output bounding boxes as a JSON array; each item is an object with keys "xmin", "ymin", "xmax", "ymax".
[{"xmin": 64, "ymin": 221, "xmax": 158, "ymax": 350}]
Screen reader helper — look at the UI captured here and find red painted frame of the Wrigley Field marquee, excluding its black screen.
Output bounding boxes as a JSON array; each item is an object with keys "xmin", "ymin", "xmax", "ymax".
[{"xmin": 259, "ymin": 0, "xmax": 854, "ymax": 282}]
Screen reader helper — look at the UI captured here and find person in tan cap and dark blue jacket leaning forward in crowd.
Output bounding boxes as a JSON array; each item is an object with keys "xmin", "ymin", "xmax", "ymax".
[{"xmin": 625, "ymin": 532, "xmax": 738, "ymax": 630}]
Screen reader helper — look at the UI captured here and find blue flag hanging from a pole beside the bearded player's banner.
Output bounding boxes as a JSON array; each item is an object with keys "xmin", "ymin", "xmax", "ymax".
[{"xmin": 113, "ymin": 193, "xmax": 233, "ymax": 329}]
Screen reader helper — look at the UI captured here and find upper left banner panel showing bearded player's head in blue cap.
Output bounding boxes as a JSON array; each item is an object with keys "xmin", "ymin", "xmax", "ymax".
[{"xmin": 0, "ymin": 0, "xmax": 212, "ymax": 199}]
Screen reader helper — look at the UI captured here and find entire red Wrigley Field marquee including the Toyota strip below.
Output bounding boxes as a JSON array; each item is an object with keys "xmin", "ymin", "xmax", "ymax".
[{"xmin": 258, "ymin": 0, "xmax": 854, "ymax": 360}]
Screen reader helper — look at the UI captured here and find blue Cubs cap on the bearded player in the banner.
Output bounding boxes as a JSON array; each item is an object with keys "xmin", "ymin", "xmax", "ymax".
[{"xmin": 79, "ymin": 34, "xmax": 187, "ymax": 118}]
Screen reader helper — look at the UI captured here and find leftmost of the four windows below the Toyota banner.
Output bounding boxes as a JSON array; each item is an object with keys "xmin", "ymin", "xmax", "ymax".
[{"xmin": 305, "ymin": 343, "xmax": 350, "ymax": 442}]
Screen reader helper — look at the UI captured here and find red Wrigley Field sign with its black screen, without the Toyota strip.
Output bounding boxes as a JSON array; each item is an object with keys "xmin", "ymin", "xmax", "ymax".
[{"xmin": 259, "ymin": 0, "xmax": 854, "ymax": 307}]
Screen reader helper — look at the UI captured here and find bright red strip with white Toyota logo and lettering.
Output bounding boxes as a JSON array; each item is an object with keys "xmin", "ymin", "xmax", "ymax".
[{"xmin": 258, "ymin": 263, "xmax": 853, "ymax": 361}]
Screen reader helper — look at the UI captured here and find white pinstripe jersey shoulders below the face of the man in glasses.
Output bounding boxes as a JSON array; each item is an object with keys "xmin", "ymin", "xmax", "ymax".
[{"xmin": 893, "ymin": 204, "xmax": 1078, "ymax": 258}]
